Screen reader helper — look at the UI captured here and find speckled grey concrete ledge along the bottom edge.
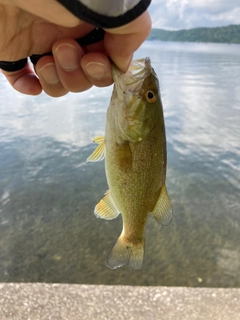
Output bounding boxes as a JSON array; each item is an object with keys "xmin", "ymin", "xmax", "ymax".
[{"xmin": 0, "ymin": 283, "xmax": 240, "ymax": 320}]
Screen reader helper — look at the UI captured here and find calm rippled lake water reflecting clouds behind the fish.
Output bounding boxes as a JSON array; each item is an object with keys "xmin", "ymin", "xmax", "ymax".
[{"xmin": 0, "ymin": 41, "xmax": 240, "ymax": 287}]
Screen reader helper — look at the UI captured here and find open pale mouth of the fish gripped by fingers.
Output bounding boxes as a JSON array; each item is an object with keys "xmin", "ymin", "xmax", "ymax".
[{"xmin": 112, "ymin": 57, "xmax": 152, "ymax": 99}]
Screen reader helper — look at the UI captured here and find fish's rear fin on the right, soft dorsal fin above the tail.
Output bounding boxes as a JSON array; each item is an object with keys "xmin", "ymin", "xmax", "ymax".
[{"xmin": 152, "ymin": 185, "xmax": 172, "ymax": 226}]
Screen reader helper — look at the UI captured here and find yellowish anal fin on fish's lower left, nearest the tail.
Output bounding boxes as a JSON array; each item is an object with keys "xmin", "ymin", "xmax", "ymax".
[{"xmin": 94, "ymin": 190, "xmax": 119, "ymax": 220}]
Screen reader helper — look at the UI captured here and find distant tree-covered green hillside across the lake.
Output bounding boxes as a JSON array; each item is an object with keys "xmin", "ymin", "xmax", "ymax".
[{"xmin": 148, "ymin": 25, "xmax": 240, "ymax": 43}]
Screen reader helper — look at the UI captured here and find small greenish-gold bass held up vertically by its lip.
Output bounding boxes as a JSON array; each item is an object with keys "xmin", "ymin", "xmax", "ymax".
[{"xmin": 87, "ymin": 57, "xmax": 172, "ymax": 269}]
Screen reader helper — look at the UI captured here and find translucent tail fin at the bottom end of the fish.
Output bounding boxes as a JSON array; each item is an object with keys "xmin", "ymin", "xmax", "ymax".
[{"xmin": 107, "ymin": 235, "xmax": 144, "ymax": 269}]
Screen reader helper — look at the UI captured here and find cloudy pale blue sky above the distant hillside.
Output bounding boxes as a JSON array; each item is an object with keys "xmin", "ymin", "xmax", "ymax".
[{"xmin": 149, "ymin": 0, "xmax": 240, "ymax": 30}]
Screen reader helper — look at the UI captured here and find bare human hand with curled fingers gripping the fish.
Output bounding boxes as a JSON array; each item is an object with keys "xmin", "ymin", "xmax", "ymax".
[{"xmin": 0, "ymin": 0, "xmax": 151, "ymax": 97}]
